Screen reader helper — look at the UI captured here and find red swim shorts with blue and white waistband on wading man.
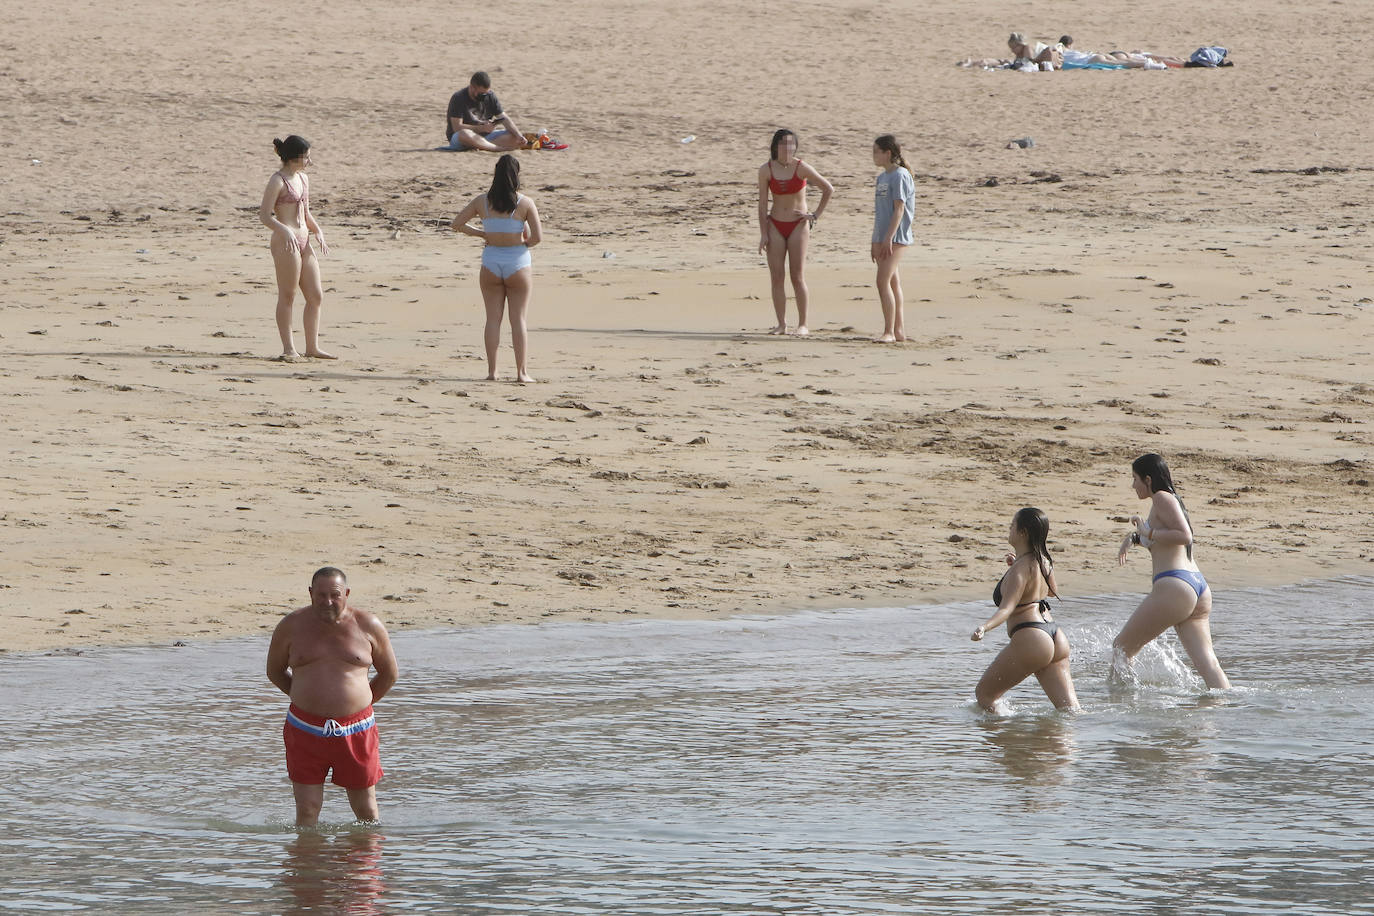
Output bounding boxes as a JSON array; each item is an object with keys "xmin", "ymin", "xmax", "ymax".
[{"xmin": 282, "ymin": 703, "xmax": 382, "ymax": 788}]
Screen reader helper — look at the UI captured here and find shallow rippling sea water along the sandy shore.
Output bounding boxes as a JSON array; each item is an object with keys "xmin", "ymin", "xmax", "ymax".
[{"xmin": 0, "ymin": 578, "xmax": 1374, "ymax": 915}]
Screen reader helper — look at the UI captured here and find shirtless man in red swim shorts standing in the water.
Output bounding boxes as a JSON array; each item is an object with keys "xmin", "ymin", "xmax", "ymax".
[{"xmin": 267, "ymin": 566, "xmax": 397, "ymax": 827}]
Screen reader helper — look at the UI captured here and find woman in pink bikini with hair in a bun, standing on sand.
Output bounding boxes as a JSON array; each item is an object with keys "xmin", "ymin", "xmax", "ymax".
[{"xmin": 258, "ymin": 133, "xmax": 335, "ymax": 360}]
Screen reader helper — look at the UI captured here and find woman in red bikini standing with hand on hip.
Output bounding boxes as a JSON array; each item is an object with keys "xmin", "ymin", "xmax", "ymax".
[{"xmin": 758, "ymin": 128, "xmax": 834, "ymax": 336}]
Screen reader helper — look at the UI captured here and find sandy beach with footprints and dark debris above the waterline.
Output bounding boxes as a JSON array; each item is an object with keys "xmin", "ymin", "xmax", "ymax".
[{"xmin": 0, "ymin": 0, "xmax": 1374, "ymax": 651}]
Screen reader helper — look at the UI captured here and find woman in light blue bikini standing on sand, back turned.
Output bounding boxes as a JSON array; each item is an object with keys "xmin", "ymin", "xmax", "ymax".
[{"xmin": 451, "ymin": 152, "xmax": 543, "ymax": 382}]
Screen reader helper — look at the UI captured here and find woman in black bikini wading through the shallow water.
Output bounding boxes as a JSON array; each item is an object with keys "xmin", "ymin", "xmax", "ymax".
[{"xmin": 971, "ymin": 508, "xmax": 1079, "ymax": 711}]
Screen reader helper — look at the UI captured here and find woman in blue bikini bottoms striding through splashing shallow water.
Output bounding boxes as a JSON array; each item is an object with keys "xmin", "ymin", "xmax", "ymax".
[{"xmin": 1112, "ymin": 453, "xmax": 1231, "ymax": 688}]
